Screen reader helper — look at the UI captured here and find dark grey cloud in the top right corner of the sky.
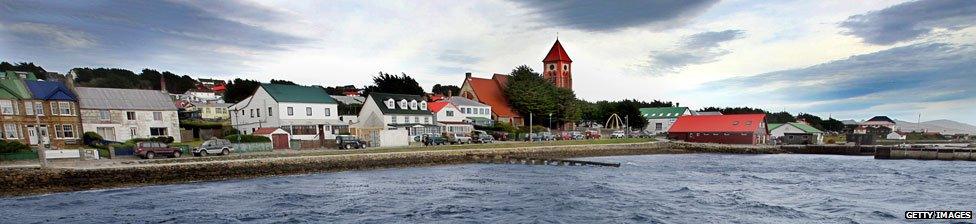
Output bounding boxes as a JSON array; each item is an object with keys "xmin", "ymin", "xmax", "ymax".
[{"xmin": 840, "ymin": 0, "xmax": 976, "ymax": 45}]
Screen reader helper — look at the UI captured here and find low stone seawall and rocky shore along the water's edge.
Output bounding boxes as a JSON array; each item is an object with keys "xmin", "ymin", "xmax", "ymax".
[{"xmin": 0, "ymin": 142, "xmax": 784, "ymax": 196}]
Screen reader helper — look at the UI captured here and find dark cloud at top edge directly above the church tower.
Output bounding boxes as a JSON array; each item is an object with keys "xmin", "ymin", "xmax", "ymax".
[{"xmin": 514, "ymin": 0, "xmax": 718, "ymax": 32}]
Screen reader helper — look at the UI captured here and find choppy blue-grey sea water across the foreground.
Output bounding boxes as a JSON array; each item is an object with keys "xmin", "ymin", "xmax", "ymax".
[{"xmin": 0, "ymin": 154, "xmax": 976, "ymax": 223}]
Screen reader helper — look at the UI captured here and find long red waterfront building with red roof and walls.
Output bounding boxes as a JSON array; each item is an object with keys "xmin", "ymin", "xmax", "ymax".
[{"xmin": 668, "ymin": 114, "xmax": 769, "ymax": 144}]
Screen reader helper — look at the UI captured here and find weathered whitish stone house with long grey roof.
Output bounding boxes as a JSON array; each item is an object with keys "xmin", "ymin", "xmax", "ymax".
[{"xmin": 75, "ymin": 87, "xmax": 181, "ymax": 142}]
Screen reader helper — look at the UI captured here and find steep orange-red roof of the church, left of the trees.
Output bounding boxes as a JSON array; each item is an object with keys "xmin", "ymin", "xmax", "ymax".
[{"xmin": 467, "ymin": 74, "xmax": 518, "ymax": 117}]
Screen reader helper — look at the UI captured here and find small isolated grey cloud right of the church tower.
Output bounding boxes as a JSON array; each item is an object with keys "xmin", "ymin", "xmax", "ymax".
[{"xmin": 644, "ymin": 30, "xmax": 745, "ymax": 76}]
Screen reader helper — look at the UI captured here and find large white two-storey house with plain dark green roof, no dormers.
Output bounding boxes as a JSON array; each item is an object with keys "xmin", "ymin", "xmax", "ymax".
[{"xmin": 229, "ymin": 83, "xmax": 342, "ymax": 140}]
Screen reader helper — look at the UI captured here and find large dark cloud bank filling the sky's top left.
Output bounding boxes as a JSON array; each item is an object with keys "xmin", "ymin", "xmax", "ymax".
[{"xmin": 0, "ymin": 1, "xmax": 307, "ymax": 72}]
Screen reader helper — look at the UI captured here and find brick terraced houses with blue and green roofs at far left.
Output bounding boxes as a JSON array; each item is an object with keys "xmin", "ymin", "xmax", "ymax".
[{"xmin": 0, "ymin": 73, "xmax": 82, "ymax": 149}]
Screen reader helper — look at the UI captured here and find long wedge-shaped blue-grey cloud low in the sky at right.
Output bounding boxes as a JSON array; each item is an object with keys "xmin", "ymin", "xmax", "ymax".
[{"xmin": 701, "ymin": 43, "xmax": 976, "ymax": 117}]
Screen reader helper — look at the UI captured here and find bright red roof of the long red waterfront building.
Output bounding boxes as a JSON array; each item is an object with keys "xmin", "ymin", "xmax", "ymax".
[{"xmin": 668, "ymin": 114, "xmax": 766, "ymax": 132}]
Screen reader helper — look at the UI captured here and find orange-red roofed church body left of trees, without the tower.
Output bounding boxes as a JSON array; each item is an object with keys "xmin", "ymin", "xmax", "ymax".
[{"xmin": 461, "ymin": 73, "xmax": 524, "ymax": 126}]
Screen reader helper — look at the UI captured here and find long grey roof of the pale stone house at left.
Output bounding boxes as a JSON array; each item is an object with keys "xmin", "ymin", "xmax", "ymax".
[{"xmin": 75, "ymin": 87, "xmax": 176, "ymax": 111}]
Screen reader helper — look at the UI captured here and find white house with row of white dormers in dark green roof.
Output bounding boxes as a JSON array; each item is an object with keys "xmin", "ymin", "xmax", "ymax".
[{"xmin": 353, "ymin": 93, "xmax": 440, "ymax": 136}]
